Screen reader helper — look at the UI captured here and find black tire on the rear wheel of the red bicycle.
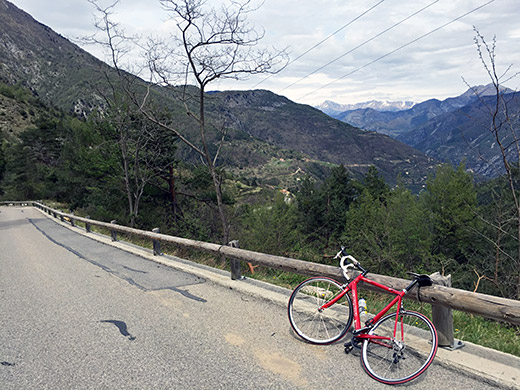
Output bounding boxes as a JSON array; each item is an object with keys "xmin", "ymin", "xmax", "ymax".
[{"xmin": 361, "ymin": 310, "xmax": 438, "ymax": 385}]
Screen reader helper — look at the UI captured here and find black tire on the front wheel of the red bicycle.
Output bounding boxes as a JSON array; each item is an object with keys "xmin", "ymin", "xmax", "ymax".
[{"xmin": 287, "ymin": 276, "xmax": 353, "ymax": 345}]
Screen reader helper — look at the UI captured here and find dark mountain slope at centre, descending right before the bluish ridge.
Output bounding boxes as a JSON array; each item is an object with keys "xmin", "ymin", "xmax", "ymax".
[{"xmin": 210, "ymin": 90, "xmax": 434, "ymax": 181}]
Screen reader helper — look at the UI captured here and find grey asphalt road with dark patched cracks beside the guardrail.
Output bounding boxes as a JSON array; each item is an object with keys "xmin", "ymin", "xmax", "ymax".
[{"xmin": 0, "ymin": 207, "xmax": 502, "ymax": 390}]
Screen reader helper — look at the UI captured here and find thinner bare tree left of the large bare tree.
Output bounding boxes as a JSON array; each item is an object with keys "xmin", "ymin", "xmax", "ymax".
[{"xmin": 82, "ymin": 0, "xmax": 176, "ymax": 225}]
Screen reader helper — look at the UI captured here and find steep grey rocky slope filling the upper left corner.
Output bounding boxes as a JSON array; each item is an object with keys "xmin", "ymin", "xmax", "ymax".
[{"xmin": 0, "ymin": 0, "xmax": 109, "ymax": 113}]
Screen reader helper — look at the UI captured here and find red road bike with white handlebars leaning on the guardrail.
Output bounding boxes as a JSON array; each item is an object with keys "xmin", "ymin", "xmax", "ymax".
[{"xmin": 287, "ymin": 248, "xmax": 438, "ymax": 384}]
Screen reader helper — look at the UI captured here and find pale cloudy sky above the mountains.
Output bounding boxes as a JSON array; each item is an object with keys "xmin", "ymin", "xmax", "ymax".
[{"xmin": 9, "ymin": 0, "xmax": 520, "ymax": 105}]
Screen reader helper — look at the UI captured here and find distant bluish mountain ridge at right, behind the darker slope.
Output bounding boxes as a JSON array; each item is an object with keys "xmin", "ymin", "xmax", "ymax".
[{"xmin": 322, "ymin": 84, "xmax": 518, "ymax": 177}]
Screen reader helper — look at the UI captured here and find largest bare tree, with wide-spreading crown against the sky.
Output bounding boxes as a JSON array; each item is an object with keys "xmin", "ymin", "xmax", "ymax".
[{"xmin": 141, "ymin": 0, "xmax": 287, "ymax": 243}]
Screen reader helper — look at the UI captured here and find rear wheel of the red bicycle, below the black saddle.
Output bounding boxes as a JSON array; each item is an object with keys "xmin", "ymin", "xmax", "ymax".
[{"xmin": 361, "ymin": 310, "xmax": 438, "ymax": 385}]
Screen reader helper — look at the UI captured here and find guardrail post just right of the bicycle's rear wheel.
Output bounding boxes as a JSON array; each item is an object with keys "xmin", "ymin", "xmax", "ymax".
[{"xmin": 430, "ymin": 272, "xmax": 464, "ymax": 350}]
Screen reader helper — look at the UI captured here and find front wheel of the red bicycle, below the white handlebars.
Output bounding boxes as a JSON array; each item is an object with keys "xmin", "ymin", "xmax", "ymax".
[{"xmin": 287, "ymin": 277, "xmax": 352, "ymax": 344}]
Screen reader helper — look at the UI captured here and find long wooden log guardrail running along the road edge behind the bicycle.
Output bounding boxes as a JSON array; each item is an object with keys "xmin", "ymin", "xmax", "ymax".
[{"xmin": 1, "ymin": 202, "xmax": 520, "ymax": 346}]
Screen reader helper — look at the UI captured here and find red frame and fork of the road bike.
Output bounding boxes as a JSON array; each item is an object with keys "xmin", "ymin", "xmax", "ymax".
[{"xmin": 319, "ymin": 273, "xmax": 407, "ymax": 339}]
